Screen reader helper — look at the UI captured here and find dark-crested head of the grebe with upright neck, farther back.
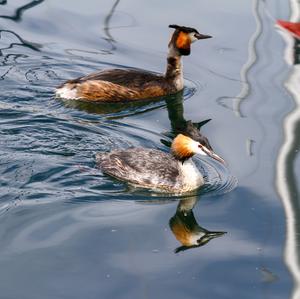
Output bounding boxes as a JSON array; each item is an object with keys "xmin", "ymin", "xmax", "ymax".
[{"xmin": 169, "ymin": 25, "xmax": 211, "ymax": 55}]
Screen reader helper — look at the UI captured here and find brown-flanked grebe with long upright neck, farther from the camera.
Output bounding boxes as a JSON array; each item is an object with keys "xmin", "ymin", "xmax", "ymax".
[{"xmin": 56, "ymin": 25, "xmax": 211, "ymax": 102}]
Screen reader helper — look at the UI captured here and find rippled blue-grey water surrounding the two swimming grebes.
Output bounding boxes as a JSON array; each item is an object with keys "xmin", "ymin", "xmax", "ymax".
[{"xmin": 0, "ymin": 0, "xmax": 300, "ymax": 299}]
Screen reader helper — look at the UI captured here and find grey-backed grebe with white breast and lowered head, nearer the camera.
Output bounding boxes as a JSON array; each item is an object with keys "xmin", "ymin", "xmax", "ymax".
[{"xmin": 96, "ymin": 134, "xmax": 224, "ymax": 193}]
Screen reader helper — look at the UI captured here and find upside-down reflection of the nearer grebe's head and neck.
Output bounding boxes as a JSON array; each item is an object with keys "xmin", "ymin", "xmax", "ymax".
[{"xmin": 169, "ymin": 197, "xmax": 226, "ymax": 253}]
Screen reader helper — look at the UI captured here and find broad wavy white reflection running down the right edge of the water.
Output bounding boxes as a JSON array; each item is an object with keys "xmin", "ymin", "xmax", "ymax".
[{"xmin": 276, "ymin": 0, "xmax": 300, "ymax": 299}]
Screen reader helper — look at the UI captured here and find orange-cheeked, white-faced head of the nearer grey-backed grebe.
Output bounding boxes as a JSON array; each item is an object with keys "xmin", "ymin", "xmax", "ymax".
[{"xmin": 171, "ymin": 134, "xmax": 225, "ymax": 164}]
